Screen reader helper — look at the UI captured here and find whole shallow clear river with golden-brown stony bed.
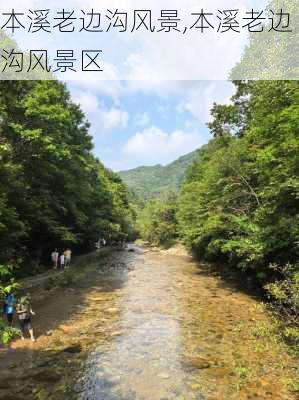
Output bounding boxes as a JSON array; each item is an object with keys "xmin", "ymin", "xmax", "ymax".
[{"xmin": 0, "ymin": 248, "xmax": 296, "ymax": 400}]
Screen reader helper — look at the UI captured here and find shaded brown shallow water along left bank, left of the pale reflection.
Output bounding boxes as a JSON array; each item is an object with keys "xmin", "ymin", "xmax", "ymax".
[{"xmin": 0, "ymin": 250, "xmax": 130, "ymax": 400}]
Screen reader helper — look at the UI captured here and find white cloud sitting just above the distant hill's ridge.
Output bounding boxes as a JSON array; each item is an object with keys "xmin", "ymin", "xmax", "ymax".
[{"xmin": 122, "ymin": 126, "xmax": 204, "ymax": 166}]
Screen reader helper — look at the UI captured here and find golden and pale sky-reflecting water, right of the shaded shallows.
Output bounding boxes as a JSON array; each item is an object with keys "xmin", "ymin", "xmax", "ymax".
[{"xmin": 76, "ymin": 247, "xmax": 291, "ymax": 400}]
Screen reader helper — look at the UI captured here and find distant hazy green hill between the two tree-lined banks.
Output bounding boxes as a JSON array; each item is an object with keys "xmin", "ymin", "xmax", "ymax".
[{"xmin": 118, "ymin": 150, "xmax": 198, "ymax": 200}]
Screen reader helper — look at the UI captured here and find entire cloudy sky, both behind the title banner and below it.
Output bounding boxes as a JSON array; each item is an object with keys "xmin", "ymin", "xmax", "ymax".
[{"xmin": 0, "ymin": 0, "xmax": 266, "ymax": 171}]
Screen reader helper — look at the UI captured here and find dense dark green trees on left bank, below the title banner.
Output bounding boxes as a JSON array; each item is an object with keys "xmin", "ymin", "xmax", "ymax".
[{"xmin": 0, "ymin": 81, "xmax": 133, "ymax": 271}]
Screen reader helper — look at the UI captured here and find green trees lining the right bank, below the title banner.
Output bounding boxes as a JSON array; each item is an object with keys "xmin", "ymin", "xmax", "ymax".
[{"xmin": 138, "ymin": 81, "xmax": 299, "ymax": 339}]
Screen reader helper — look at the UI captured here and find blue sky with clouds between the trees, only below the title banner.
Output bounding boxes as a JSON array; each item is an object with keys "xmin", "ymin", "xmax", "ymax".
[{"xmin": 67, "ymin": 81, "xmax": 233, "ymax": 171}]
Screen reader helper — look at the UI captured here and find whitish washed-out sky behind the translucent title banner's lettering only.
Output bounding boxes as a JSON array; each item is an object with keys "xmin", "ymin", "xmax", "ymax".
[{"xmin": 9, "ymin": 0, "xmax": 272, "ymax": 81}]
